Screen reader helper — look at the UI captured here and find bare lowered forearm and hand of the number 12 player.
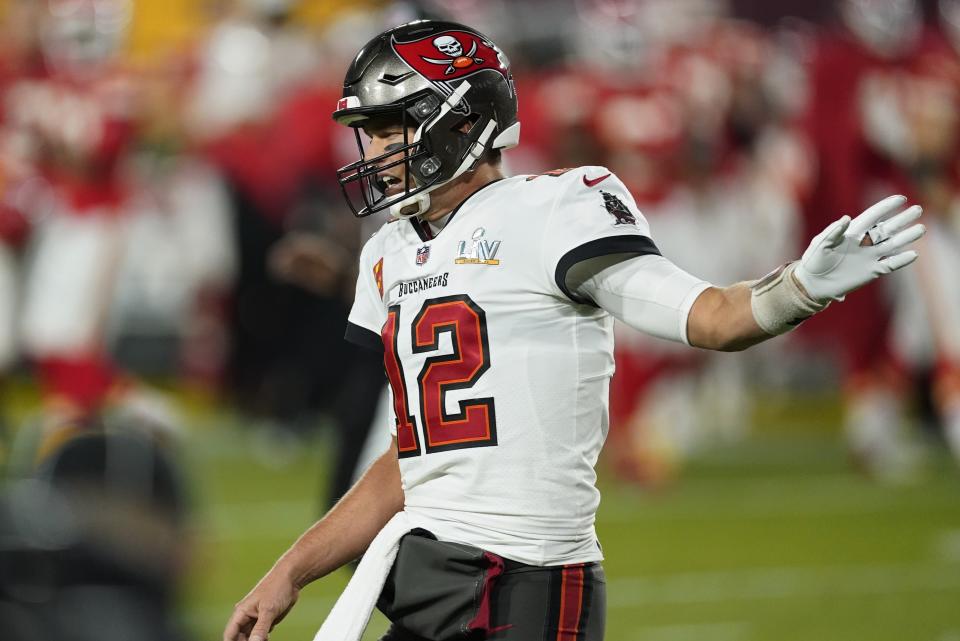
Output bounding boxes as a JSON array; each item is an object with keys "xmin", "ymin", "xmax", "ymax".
[{"xmin": 223, "ymin": 441, "xmax": 404, "ymax": 641}]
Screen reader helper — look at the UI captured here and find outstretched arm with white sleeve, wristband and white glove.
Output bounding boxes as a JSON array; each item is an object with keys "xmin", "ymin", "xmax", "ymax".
[{"xmin": 580, "ymin": 196, "xmax": 925, "ymax": 351}]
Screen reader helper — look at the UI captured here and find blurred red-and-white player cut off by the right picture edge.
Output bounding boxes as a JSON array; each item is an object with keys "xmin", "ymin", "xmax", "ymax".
[{"xmin": 866, "ymin": 0, "xmax": 960, "ymax": 461}]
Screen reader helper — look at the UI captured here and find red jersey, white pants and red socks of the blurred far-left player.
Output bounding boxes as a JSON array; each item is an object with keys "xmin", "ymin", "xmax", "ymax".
[{"xmin": 7, "ymin": 62, "xmax": 134, "ymax": 413}]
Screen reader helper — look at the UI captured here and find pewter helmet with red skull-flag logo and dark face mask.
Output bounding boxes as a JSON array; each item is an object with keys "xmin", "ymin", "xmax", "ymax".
[{"xmin": 333, "ymin": 20, "xmax": 520, "ymax": 218}]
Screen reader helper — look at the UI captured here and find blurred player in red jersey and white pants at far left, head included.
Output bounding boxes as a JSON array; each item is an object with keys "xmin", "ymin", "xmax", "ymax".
[{"xmin": 0, "ymin": 0, "xmax": 182, "ymax": 440}]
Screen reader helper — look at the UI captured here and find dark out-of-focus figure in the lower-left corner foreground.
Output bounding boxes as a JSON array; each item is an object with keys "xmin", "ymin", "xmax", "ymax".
[{"xmin": 0, "ymin": 424, "xmax": 189, "ymax": 641}]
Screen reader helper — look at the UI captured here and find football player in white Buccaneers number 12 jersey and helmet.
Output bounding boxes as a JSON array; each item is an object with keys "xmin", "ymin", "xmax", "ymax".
[{"xmin": 223, "ymin": 21, "xmax": 924, "ymax": 641}]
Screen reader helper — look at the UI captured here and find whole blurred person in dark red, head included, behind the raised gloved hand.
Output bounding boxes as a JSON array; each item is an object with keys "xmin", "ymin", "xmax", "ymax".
[{"xmin": 801, "ymin": 0, "xmax": 960, "ymax": 472}]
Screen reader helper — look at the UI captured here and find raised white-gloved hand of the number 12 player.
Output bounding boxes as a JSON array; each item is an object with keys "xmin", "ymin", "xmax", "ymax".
[{"xmin": 794, "ymin": 196, "xmax": 926, "ymax": 302}]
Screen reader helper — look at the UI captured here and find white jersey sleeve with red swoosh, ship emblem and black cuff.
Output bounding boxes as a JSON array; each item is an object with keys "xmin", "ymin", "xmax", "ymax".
[{"xmin": 542, "ymin": 167, "xmax": 660, "ymax": 305}]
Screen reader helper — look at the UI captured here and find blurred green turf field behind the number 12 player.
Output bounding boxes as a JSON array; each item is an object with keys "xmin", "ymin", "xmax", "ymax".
[{"xmin": 183, "ymin": 416, "xmax": 960, "ymax": 641}]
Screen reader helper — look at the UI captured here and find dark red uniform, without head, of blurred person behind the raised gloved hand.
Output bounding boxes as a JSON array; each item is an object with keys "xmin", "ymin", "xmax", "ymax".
[{"xmin": 800, "ymin": 15, "xmax": 960, "ymax": 476}]
